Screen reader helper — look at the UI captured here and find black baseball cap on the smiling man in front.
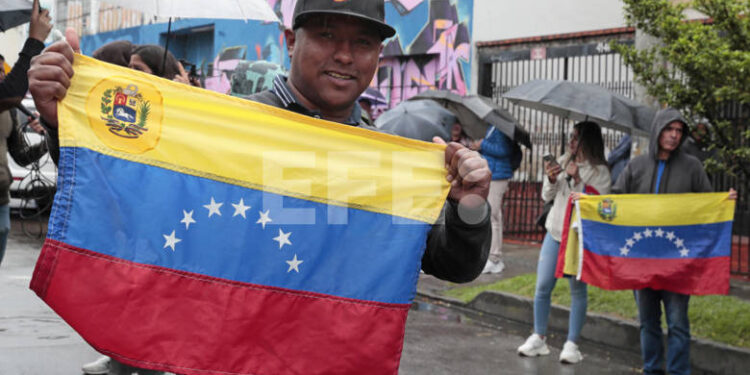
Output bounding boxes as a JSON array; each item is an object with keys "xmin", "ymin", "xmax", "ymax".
[{"xmin": 292, "ymin": 0, "xmax": 396, "ymax": 39}]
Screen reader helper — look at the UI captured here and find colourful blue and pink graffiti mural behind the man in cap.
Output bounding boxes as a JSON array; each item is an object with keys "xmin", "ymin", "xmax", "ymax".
[{"xmin": 82, "ymin": 0, "xmax": 474, "ymax": 115}]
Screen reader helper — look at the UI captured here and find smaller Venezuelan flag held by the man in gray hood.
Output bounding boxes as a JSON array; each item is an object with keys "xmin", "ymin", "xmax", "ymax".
[{"xmin": 567, "ymin": 192, "xmax": 735, "ymax": 295}]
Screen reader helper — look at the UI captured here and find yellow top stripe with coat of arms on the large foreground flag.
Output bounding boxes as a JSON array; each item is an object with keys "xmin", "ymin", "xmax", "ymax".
[{"xmin": 58, "ymin": 55, "xmax": 449, "ymax": 223}]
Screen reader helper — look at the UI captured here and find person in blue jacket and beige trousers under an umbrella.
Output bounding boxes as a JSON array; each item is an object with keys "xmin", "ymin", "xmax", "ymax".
[{"xmin": 473, "ymin": 125, "xmax": 513, "ymax": 273}]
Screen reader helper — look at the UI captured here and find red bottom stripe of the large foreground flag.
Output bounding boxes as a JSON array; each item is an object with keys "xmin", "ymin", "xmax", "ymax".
[{"xmin": 31, "ymin": 240, "xmax": 409, "ymax": 375}]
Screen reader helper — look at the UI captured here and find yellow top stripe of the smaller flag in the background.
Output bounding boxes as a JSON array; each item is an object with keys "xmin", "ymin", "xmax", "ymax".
[{"xmin": 579, "ymin": 192, "xmax": 735, "ymax": 226}]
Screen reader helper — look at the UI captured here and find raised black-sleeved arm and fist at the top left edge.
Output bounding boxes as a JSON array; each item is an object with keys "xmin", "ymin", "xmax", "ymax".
[{"xmin": 0, "ymin": 0, "xmax": 52, "ymax": 111}]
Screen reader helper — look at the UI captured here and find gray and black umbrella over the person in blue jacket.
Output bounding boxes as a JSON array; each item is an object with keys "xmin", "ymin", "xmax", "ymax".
[{"xmin": 409, "ymin": 90, "xmax": 531, "ymax": 148}]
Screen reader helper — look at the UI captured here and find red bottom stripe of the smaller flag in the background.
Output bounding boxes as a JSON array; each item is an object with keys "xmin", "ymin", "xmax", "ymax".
[{"xmin": 581, "ymin": 249, "xmax": 729, "ymax": 295}]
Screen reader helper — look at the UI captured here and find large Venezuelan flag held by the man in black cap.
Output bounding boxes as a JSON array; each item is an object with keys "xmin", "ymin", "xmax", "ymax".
[{"xmin": 31, "ymin": 55, "xmax": 449, "ymax": 375}]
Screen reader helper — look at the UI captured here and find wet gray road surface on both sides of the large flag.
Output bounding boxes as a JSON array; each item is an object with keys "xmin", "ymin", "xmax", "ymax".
[{"xmin": 0, "ymin": 221, "xmax": 648, "ymax": 375}]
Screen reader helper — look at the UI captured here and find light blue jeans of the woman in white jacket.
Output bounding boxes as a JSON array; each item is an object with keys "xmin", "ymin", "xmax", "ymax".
[{"xmin": 534, "ymin": 233, "xmax": 588, "ymax": 342}]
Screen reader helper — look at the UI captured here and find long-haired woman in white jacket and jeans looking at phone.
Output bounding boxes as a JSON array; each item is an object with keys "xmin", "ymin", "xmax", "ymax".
[{"xmin": 518, "ymin": 121, "xmax": 611, "ymax": 363}]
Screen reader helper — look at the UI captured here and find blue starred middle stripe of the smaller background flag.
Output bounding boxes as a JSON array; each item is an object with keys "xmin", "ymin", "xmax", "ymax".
[{"xmin": 581, "ymin": 220, "xmax": 732, "ymax": 259}]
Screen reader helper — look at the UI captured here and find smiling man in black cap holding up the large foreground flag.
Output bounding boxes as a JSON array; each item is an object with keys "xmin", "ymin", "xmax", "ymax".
[{"xmin": 29, "ymin": 0, "xmax": 492, "ymax": 326}]
